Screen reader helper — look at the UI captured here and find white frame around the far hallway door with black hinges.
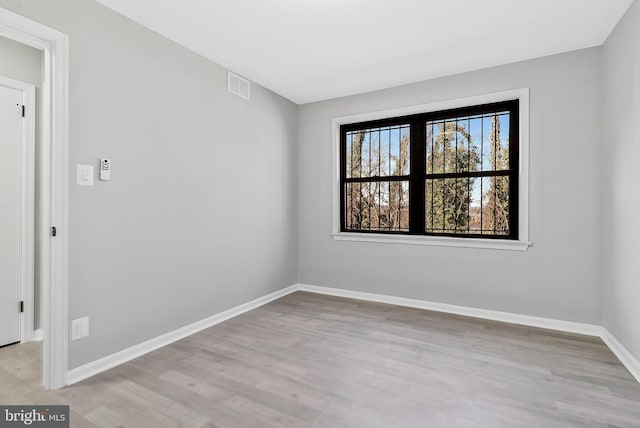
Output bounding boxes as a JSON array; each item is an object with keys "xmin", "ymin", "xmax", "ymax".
[{"xmin": 0, "ymin": 76, "xmax": 36, "ymax": 343}]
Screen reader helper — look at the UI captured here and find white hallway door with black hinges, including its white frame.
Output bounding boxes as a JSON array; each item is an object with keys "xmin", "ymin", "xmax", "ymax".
[{"xmin": 0, "ymin": 76, "xmax": 36, "ymax": 346}]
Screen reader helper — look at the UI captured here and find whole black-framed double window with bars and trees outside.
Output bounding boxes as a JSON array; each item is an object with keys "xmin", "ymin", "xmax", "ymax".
[{"xmin": 340, "ymin": 100, "xmax": 519, "ymax": 240}]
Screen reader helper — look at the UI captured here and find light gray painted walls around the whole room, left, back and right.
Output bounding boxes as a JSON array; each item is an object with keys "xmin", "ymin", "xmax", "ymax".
[{"xmin": 0, "ymin": 0, "xmax": 640, "ymax": 368}]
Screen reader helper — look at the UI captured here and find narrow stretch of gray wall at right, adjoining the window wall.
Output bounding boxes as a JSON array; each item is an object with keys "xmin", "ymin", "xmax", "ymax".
[{"xmin": 603, "ymin": 0, "xmax": 640, "ymax": 360}]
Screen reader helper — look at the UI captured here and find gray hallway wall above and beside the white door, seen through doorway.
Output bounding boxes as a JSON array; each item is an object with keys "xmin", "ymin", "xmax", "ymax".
[{"xmin": 0, "ymin": 37, "xmax": 42, "ymax": 329}]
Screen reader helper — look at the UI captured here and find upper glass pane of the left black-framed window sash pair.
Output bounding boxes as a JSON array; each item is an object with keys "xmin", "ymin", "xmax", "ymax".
[{"xmin": 346, "ymin": 124, "xmax": 410, "ymax": 178}]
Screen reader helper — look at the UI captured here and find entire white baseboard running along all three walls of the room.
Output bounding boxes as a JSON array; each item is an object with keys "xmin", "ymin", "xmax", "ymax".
[{"xmin": 65, "ymin": 284, "xmax": 640, "ymax": 385}]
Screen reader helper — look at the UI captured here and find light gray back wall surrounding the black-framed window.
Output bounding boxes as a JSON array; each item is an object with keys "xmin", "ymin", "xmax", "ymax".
[{"xmin": 298, "ymin": 48, "xmax": 602, "ymax": 324}]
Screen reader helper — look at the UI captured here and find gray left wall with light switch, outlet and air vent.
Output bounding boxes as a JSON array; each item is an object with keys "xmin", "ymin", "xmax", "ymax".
[{"xmin": 3, "ymin": 0, "xmax": 297, "ymax": 368}]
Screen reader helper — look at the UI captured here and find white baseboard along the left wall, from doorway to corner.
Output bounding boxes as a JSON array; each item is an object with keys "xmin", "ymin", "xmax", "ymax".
[{"xmin": 67, "ymin": 285, "xmax": 298, "ymax": 385}]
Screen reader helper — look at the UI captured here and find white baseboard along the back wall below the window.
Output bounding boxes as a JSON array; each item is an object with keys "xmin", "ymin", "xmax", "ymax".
[{"xmin": 298, "ymin": 284, "xmax": 602, "ymax": 336}]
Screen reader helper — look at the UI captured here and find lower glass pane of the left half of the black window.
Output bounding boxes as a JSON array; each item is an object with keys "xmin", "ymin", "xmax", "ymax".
[{"xmin": 345, "ymin": 181, "xmax": 409, "ymax": 232}]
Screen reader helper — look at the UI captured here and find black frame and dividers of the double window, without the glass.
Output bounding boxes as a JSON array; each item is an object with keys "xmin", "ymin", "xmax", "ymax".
[{"xmin": 339, "ymin": 99, "xmax": 520, "ymax": 241}]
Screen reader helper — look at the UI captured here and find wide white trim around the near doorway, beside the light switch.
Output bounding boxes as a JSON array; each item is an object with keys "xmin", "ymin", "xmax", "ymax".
[{"xmin": 0, "ymin": 8, "xmax": 69, "ymax": 389}]
